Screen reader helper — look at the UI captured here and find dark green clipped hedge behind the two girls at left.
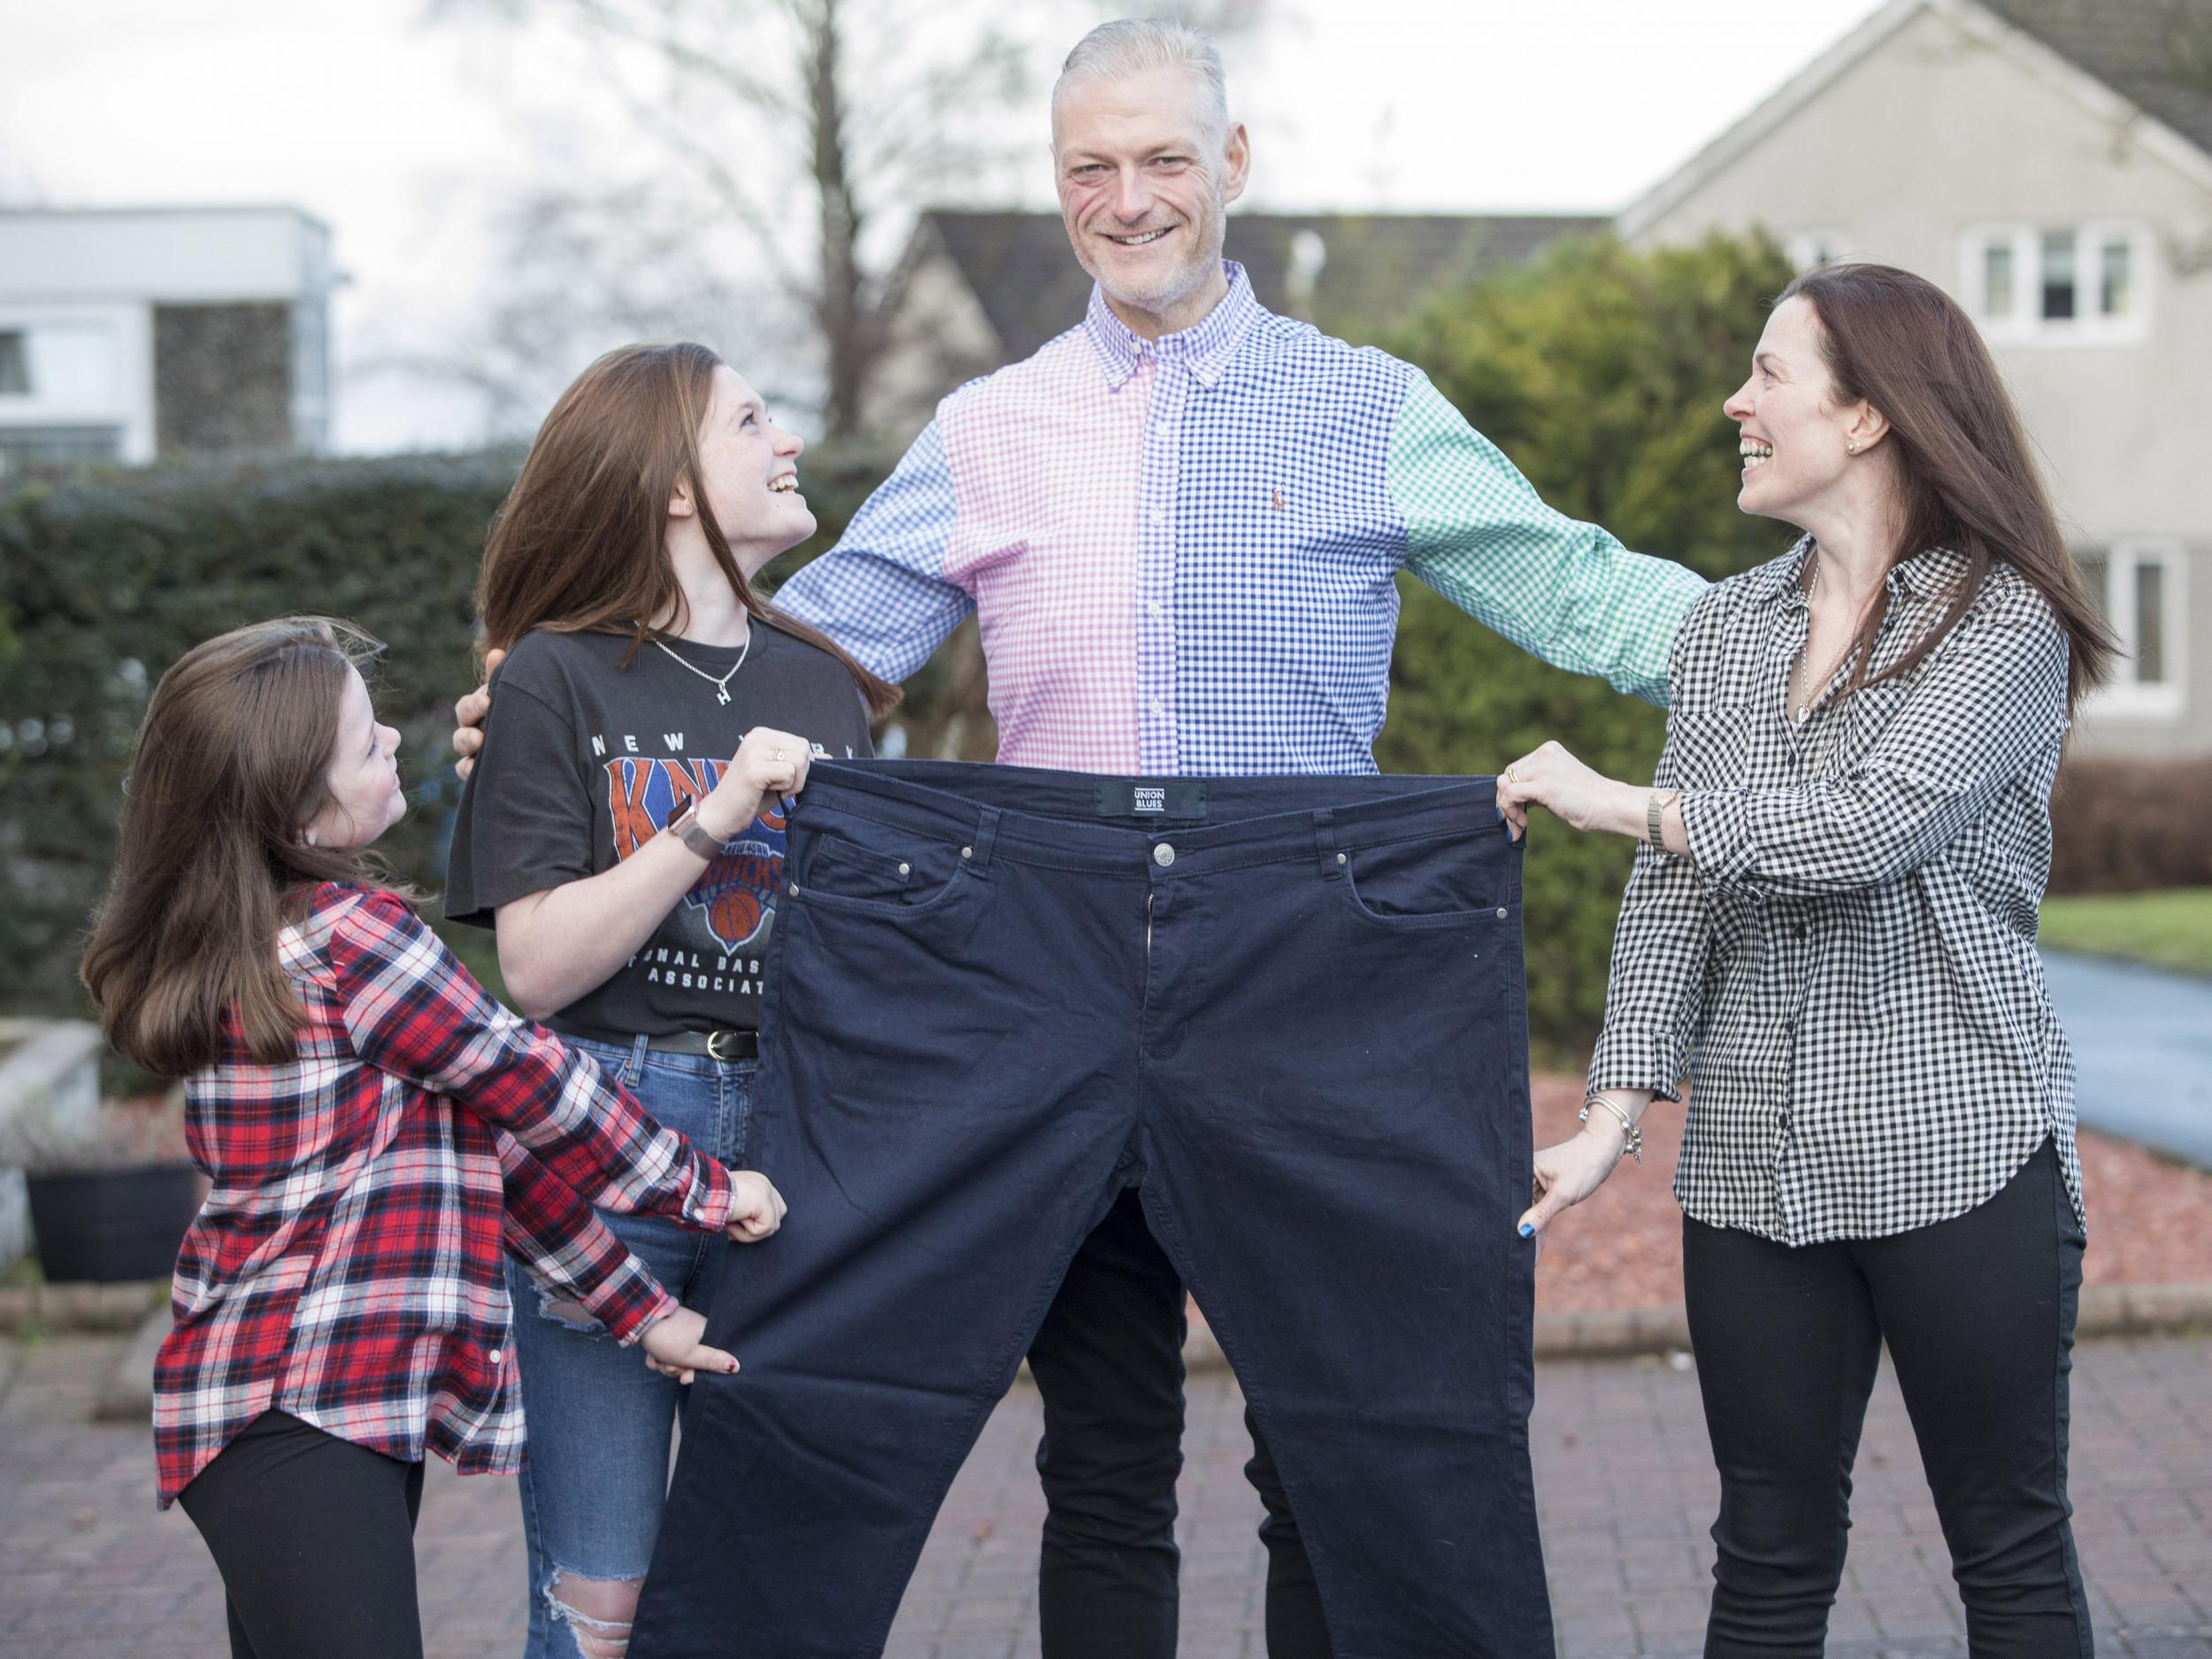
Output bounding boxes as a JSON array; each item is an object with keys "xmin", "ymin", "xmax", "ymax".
[{"xmin": 0, "ymin": 451, "xmax": 932, "ymax": 1013}]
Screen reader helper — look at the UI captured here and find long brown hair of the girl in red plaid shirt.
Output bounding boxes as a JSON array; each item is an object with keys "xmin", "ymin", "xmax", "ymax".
[{"xmin": 80, "ymin": 618, "xmax": 407, "ymax": 1078}]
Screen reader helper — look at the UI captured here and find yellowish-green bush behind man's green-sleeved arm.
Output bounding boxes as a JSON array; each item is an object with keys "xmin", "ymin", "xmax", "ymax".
[{"xmin": 1376, "ymin": 239, "xmax": 1794, "ymax": 1064}]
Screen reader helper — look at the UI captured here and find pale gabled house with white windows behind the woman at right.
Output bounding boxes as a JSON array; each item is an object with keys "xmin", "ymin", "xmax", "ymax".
[{"xmin": 1619, "ymin": 0, "xmax": 2212, "ymax": 757}]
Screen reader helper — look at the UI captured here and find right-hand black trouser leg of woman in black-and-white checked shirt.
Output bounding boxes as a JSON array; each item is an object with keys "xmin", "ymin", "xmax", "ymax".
[{"xmin": 1858, "ymin": 1141, "xmax": 2091, "ymax": 1659}]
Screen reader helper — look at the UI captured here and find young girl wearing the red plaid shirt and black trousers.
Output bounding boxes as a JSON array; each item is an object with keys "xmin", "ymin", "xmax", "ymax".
[{"xmin": 84, "ymin": 618, "xmax": 787, "ymax": 1659}]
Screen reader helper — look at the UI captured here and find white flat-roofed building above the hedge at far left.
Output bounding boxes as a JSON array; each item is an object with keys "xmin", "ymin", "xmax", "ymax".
[{"xmin": 0, "ymin": 208, "xmax": 339, "ymax": 485}]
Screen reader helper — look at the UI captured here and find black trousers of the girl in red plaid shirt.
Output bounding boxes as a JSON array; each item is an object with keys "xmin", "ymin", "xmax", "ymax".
[{"xmin": 177, "ymin": 1411, "xmax": 423, "ymax": 1659}]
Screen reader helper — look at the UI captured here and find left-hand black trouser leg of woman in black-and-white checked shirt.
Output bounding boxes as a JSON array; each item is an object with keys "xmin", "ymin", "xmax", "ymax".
[{"xmin": 1681, "ymin": 1217, "xmax": 1883, "ymax": 1659}]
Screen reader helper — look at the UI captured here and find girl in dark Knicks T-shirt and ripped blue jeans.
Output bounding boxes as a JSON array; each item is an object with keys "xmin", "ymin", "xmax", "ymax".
[{"xmin": 447, "ymin": 345, "xmax": 896, "ymax": 1659}]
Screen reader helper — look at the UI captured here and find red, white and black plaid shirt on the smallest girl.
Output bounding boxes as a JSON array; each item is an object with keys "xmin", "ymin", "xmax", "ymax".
[{"xmin": 153, "ymin": 883, "xmax": 730, "ymax": 1509}]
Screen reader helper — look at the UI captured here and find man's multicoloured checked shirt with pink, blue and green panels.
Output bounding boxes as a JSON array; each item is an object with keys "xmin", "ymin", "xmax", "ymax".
[{"xmin": 777, "ymin": 264, "xmax": 1706, "ymax": 774}]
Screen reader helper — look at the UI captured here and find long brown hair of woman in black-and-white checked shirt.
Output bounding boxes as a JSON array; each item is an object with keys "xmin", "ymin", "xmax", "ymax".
[{"xmin": 1777, "ymin": 264, "xmax": 2115, "ymax": 710}]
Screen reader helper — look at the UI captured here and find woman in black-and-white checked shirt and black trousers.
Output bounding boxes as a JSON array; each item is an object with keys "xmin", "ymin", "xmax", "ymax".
[{"xmin": 1498, "ymin": 265, "xmax": 2110, "ymax": 1659}]
